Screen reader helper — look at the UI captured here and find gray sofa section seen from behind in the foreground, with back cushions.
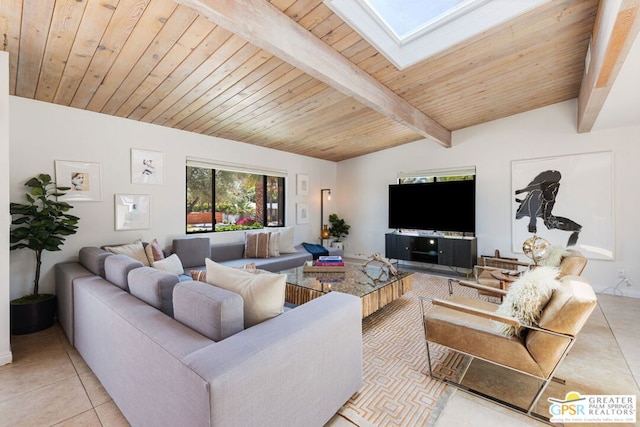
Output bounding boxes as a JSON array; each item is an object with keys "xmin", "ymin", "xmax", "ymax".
[{"xmin": 55, "ymin": 244, "xmax": 362, "ymax": 426}]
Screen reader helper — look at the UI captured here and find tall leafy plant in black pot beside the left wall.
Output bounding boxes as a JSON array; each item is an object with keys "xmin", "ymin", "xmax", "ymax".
[{"xmin": 9, "ymin": 174, "xmax": 79, "ymax": 334}]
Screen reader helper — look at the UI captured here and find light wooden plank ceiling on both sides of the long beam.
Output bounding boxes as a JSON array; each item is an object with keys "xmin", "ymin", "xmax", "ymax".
[{"xmin": 0, "ymin": 0, "xmax": 598, "ymax": 161}]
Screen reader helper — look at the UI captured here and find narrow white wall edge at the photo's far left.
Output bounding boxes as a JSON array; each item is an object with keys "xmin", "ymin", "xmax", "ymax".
[{"xmin": 0, "ymin": 52, "xmax": 12, "ymax": 365}]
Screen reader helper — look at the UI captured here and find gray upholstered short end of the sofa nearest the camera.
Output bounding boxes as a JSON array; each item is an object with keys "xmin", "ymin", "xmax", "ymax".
[{"xmin": 185, "ymin": 292, "xmax": 362, "ymax": 426}]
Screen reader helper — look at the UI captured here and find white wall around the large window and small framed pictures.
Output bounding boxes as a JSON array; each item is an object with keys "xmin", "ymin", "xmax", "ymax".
[{"xmin": 8, "ymin": 97, "xmax": 338, "ymax": 302}]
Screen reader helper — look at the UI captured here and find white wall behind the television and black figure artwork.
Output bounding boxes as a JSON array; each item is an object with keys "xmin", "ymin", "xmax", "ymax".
[{"xmin": 338, "ymin": 100, "xmax": 640, "ymax": 296}]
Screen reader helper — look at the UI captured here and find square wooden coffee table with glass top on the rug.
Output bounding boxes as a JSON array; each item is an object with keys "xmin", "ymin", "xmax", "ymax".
[{"xmin": 281, "ymin": 263, "xmax": 413, "ymax": 318}]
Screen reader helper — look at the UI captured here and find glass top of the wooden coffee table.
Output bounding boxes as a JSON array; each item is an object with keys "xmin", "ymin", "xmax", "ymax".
[{"xmin": 280, "ymin": 263, "xmax": 412, "ymax": 297}]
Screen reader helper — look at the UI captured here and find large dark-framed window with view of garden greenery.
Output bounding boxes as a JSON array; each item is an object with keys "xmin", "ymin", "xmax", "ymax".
[{"xmin": 186, "ymin": 162, "xmax": 285, "ymax": 233}]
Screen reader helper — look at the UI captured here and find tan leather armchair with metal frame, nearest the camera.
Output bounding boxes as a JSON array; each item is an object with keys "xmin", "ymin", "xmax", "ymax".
[{"xmin": 420, "ymin": 276, "xmax": 597, "ymax": 421}]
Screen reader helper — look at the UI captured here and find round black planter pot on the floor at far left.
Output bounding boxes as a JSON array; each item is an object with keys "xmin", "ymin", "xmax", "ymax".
[{"xmin": 11, "ymin": 294, "xmax": 56, "ymax": 335}]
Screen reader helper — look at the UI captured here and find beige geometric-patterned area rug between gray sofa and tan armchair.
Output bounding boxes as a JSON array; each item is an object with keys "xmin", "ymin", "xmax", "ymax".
[{"xmin": 338, "ymin": 273, "xmax": 468, "ymax": 427}]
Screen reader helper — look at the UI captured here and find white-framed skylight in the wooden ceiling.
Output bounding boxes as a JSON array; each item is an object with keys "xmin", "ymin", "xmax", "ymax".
[{"xmin": 324, "ymin": 0, "xmax": 551, "ymax": 69}]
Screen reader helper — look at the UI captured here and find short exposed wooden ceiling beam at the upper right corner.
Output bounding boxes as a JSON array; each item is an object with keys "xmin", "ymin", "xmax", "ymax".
[{"xmin": 578, "ymin": 0, "xmax": 640, "ymax": 133}]
